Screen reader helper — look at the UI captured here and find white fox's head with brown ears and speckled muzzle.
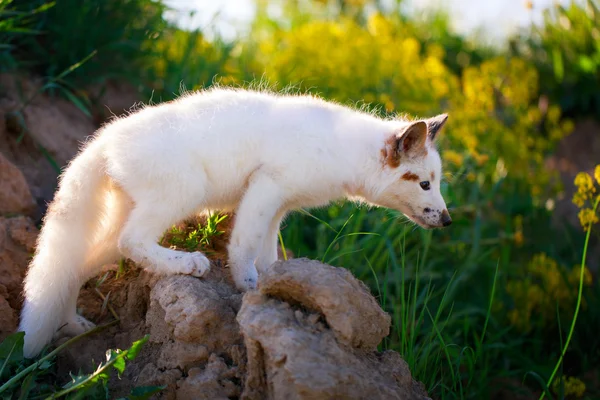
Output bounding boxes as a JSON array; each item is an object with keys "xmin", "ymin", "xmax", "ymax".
[{"xmin": 372, "ymin": 114, "xmax": 452, "ymax": 228}]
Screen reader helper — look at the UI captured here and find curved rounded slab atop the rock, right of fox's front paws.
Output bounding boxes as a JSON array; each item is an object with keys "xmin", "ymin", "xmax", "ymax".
[{"xmin": 259, "ymin": 259, "xmax": 391, "ymax": 349}]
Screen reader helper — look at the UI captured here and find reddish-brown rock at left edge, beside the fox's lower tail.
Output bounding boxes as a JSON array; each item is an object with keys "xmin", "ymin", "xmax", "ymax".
[{"xmin": 0, "ymin": 216, "xmax": 38, "ymax": 341}]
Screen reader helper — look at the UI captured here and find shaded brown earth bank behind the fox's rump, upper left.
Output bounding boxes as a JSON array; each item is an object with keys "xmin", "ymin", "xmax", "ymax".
[{"xmin": 0, "ymin": 73, "xmax": 96, "ymax": 219}]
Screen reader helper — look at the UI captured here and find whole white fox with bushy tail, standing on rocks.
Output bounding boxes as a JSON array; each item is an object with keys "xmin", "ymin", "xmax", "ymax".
[{"xmin": 19, "ymin": 88, "xmax": 451, "ymax": 357}]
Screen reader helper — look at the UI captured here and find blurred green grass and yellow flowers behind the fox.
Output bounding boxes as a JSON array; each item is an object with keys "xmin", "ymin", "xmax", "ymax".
[{"xmin": 0, "ymin": 0, "xmax": 600, "ymax": 399}]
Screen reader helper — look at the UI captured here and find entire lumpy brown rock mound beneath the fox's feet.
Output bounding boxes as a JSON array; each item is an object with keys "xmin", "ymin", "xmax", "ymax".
[{"xmin": 51, "ymin": 259, "xmax": 426, "ymax": 399}]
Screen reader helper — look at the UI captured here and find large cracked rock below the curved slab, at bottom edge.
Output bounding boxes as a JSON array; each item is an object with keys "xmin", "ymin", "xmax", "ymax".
[{"xmin": 238, "ymin": 292, "xmax": 427, "ymax": 400}]
